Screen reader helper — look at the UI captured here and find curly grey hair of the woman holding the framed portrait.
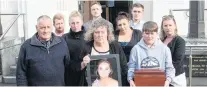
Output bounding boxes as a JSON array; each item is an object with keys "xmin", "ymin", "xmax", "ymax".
[{"xmin": 84, "ymin": 19, "xmax": 114, "ymax": 43}]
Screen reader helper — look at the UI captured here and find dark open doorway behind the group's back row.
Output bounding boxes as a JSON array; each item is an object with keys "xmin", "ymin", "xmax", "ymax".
[{"xmin": 79, "ymin": 0, "xmax": 133, "ymax": 30}]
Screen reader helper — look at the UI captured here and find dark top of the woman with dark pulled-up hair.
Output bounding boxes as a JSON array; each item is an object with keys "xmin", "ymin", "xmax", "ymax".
[{"xmin": 114, "ymin": 29, "xmax": 142, "ymax": 62}]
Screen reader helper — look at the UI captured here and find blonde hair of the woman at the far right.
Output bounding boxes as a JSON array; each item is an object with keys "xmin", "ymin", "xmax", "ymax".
[{"xmin": 160, "ymin": 15, "xmax": 178, "ymax": 40}]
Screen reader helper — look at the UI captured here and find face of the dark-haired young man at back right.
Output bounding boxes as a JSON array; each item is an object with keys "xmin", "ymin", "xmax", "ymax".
[{"xmin": 132, "ymin": 7, "xmax": 144, "ymax": 20}]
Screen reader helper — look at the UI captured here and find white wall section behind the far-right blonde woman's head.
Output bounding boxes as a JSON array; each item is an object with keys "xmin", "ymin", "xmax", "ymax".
[{"xmin": 153, "ymin": 0, "xmax": 189, "ymax": 36}]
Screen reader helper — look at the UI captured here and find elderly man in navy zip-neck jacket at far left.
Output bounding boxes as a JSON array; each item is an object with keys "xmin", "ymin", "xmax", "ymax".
[{"xmin": 16, "ymin": 15, "xmax": 69, "ymax": 86}]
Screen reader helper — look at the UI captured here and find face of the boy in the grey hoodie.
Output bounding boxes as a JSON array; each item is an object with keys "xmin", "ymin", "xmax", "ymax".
[{"xmin": 142, "ymin": 31, "xmax": 158, "ymax": 45}]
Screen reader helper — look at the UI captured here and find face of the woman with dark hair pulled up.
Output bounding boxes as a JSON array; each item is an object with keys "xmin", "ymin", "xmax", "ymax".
[{"xmin": 117, "ymin": 19, "xmax": 130, "ymax": 31}]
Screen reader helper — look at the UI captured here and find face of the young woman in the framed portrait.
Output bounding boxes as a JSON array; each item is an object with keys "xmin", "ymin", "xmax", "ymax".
[{"xmin": 98, "ymin": 62, "xmax": 111, "ymax": 78}]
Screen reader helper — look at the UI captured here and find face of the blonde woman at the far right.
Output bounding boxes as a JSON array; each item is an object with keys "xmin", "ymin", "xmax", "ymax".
[{"xmin": 162, "ymin": 20, "xmax": 176, "ymax": 36}]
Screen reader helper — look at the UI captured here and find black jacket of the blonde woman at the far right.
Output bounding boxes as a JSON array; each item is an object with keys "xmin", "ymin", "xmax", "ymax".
[{"xmin": 165, "ymin": 36, "xmax": 185, "ymax": 76}]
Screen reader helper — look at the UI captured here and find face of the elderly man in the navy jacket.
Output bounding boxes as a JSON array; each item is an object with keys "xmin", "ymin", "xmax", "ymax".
[{"xmin": 36, "ymin": 19, "xmax": 52, "ymax": 41}]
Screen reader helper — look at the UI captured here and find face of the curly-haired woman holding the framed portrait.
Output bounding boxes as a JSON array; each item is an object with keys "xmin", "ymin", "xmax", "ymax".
[{"xmin": 93, "ymin": 26, "xmax": 108, "ymax": 43}]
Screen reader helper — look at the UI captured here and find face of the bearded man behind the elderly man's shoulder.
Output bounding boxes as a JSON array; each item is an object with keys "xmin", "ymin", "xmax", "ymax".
[{"xmin": 54, "ymin": 19, "xmax": 65, "ymax": 32}]
